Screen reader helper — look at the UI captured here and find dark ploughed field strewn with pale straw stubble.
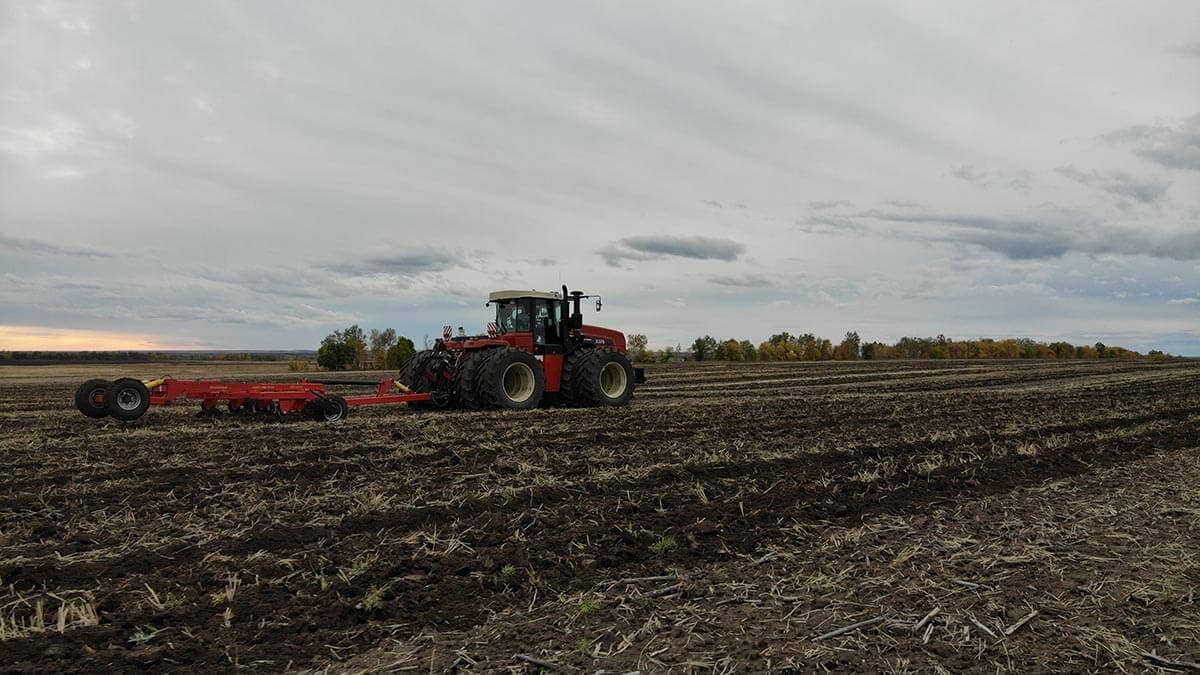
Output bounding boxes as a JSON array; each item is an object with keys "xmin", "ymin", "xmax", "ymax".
[{"xmin": 0, "ymin": 360, "xmax": 1200, "ymax": 673}]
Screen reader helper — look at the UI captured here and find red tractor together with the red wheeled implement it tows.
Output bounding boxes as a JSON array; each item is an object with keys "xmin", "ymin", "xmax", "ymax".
[{"xmin": 76, "ymin": 286, "xmax": 646, "ymax": 422}]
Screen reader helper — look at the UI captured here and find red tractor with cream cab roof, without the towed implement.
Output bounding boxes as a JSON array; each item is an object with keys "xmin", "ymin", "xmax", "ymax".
[{"xmin": 398, "ymin": 286, "xmax": 646, "ymax": 410}]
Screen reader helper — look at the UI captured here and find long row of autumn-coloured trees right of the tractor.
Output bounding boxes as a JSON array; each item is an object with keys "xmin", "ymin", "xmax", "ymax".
[{"xmin": 629, "ymin": 331, "xmax": 1174, "ymax": 363}]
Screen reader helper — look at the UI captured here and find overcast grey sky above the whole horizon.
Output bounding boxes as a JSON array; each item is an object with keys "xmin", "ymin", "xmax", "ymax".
[{"xmin": 0, "ymin": 0, "xmax": 1200, "ymax": 356}]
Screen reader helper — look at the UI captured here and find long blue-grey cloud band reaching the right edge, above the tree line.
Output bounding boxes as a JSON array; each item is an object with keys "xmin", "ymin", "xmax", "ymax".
[{"xmin": 799, "ymin": 209, "xmax": 1200, "ymax": 261}]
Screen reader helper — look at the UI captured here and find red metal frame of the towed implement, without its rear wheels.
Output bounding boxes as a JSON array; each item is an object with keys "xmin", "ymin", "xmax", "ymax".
[{"xmin": 148, "ymin": 377, "xmax": 433, "ymax": 414}]
